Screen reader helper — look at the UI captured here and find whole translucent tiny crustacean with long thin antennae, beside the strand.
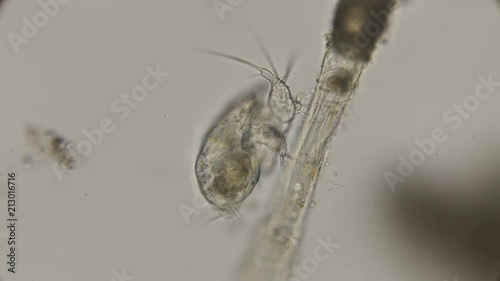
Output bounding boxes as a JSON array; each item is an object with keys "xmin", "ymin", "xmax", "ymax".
[{"xmin": 195, "ymin": 45, "xmax": 301, "ymax": 220}]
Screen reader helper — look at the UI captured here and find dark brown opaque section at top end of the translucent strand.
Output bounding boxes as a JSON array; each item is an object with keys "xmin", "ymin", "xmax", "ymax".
[{"xmin": 331, "ymin": 0, "xmax": 396, "ymax": 62}]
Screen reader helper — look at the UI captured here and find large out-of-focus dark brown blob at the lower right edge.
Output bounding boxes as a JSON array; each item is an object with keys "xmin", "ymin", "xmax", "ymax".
[{"xmin": 385, "ymin": 174, "xmax": 500, "ymax": 276}]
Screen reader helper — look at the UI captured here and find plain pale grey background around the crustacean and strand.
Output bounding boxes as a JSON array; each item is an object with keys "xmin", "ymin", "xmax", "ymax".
[{"xmin": 0, "ymin": 0, "xmax": 500, "ymax": 281}]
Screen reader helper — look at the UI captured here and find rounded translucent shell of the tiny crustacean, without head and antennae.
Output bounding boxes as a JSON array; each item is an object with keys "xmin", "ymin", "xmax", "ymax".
[{"xmin": 195, "ymin": 85, "xmax": 265, "ymax": 216}]
